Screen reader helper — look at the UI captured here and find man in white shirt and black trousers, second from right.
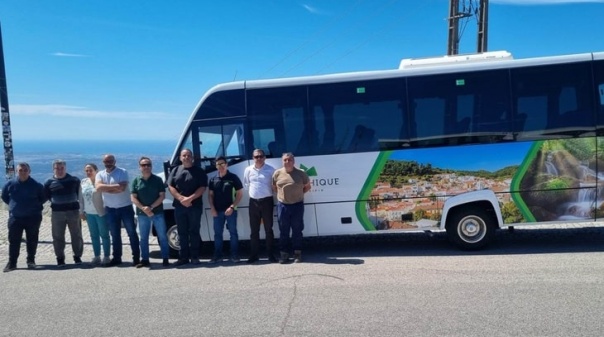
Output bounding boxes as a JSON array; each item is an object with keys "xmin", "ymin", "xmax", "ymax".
[{"xmin": 243, "ymin": 149, "xmax": 277, "ymax": 263}]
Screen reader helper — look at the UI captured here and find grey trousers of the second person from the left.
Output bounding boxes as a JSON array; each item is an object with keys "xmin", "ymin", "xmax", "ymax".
[{"xmin": 50, "ymin": 209, "xmax": 84, "ymax": 260}]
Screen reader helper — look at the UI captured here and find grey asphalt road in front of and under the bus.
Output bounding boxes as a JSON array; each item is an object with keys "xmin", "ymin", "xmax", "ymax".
[{"xmin": 0, "ymin": 223, "xmax": 604, "ymax": 336}]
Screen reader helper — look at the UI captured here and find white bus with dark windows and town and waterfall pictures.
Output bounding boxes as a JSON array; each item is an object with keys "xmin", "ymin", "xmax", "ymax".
[{"xmin": 159, "ymin": 52, "xmax": 604, "ymax": 249}]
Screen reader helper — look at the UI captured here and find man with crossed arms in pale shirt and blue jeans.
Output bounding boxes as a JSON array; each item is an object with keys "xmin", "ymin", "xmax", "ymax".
[{"xmin": 94, "ymin": 154, "xmax": 141, "ymax": 267}]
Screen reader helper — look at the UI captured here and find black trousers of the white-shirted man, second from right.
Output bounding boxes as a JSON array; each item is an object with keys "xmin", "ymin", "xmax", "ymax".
[{"xmin": 249, "ymin": 197, "xmax": 275, "ymax": 257}]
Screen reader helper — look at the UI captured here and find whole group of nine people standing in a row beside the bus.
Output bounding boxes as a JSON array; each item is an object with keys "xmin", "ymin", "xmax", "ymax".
[{"xmin": 2, "ymin": 149, "xmax": 310, "ymax": 272}]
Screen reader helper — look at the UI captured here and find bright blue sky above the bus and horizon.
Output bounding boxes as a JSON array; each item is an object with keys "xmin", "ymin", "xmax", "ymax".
[{"xmin": 0, "ymin": 0, "xmax": 604, "ymax": 142}]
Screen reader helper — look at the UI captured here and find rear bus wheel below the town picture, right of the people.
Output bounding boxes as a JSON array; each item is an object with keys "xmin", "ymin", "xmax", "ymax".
[{"xmin": 446, "ymin": 207, "xmax": 497, "ymax": 250}]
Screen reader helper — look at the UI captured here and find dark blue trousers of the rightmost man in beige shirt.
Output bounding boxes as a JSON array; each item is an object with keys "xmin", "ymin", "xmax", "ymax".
[{"xmin": 277, "ymin": 202, "xmax": 304, "ymax": 253}]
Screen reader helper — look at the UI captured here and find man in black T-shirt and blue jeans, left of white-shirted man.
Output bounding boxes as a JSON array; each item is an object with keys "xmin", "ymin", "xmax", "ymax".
[{"xmin": 208, "ymin": 157, "xmax": 243, "ymax": 263}]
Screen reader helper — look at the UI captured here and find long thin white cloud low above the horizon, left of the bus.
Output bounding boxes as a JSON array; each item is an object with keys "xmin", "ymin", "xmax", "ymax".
[{"xmin": 10, "ymin": 104, "xmax": 180, "ymax": 120}]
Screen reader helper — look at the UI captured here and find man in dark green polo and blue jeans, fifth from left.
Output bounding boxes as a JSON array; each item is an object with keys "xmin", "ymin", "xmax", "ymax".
[{"xmin": 130, "ymin": 157, "xmax": 170, "ymax": 268}]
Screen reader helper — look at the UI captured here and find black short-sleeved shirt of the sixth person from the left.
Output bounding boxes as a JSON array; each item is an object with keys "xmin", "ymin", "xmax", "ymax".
[{"xmin": 167, "ymin": 165, "xmax": 208, "ymax": 207}]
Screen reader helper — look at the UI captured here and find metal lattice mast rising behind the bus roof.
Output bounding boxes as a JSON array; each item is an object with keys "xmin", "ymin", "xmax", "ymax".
[{"xmin": 447, "ymin": 0, "xmax": 489, "ymax": 55}]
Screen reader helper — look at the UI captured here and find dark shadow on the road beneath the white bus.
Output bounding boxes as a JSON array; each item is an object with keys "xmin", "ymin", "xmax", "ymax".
[{"xmin": 145, "ymin": 227, "xmax": 604, "ymax": 268}]
